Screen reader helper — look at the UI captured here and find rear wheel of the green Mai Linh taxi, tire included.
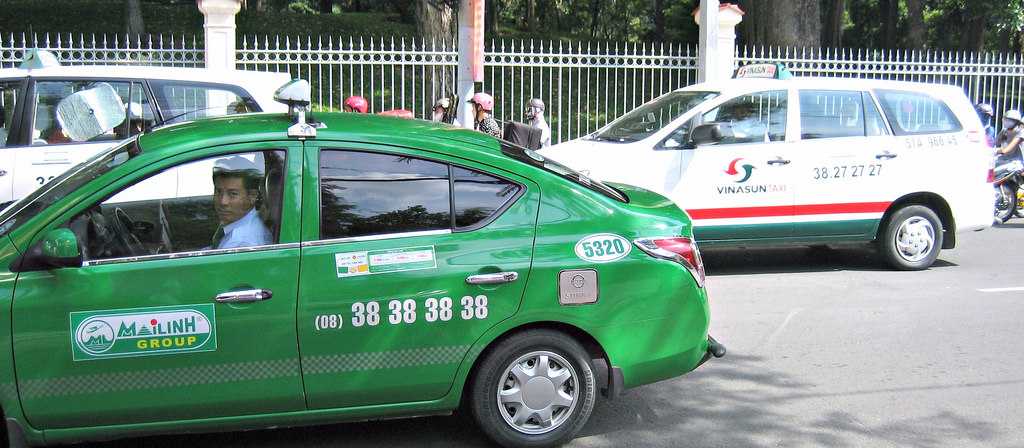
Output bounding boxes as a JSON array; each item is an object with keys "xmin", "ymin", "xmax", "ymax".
[{"xmin": 470, "ymin": 330, "xmax": 597, "ymax": 447}]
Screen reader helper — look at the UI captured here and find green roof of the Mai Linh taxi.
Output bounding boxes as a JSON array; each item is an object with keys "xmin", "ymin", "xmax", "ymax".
[{"xmin": 139, "ymin": 113, "xmax": 501, "ymax": 160}]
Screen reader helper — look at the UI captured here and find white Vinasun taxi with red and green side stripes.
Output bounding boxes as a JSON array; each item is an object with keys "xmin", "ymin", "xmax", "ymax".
[{"xmin": 541, "ymin": 66, "xmax": 993, "ymax": 269}]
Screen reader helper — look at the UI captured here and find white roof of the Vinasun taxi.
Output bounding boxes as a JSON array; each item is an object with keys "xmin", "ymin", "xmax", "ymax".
[{"xmin": 677, "ymin": 77, "xmax": 963, "ymax": 94}]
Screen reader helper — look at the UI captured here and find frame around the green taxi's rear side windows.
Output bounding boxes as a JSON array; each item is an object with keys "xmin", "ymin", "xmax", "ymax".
[{"xmin": 311, "ymin": 145, "xmax": 529, "ymax": 247}]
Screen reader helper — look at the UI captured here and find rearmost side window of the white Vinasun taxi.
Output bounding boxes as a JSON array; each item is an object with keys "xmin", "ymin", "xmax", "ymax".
[{"xmin": 876, "ymin": 90, "xmax": 963, "ymax": 135}]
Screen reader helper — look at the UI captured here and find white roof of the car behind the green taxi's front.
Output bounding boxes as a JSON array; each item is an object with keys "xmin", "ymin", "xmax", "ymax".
[{"xmin": 0, "ymin": 65, "xmax": 287, "ymax": 84}]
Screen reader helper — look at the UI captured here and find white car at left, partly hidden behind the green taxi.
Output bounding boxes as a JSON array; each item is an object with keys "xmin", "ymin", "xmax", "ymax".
[{"xmin": 0, "ymin": 60, "xmax": 290, "ymax": 206}]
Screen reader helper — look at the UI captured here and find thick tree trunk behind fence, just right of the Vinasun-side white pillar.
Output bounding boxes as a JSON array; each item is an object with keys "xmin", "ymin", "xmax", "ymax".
[{"xmin": 765, "ymin": 0, "xmax": 821, "ymax": 47}]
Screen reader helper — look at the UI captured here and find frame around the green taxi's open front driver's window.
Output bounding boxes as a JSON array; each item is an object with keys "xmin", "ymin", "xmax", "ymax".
[{"xmin": 24, "ymin": 140, "xmax": 302, "ymax": 268}]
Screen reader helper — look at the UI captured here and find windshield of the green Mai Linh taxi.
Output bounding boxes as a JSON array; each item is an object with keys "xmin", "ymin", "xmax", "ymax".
[{"xmin": 0, "ymin": 139, "xmax": 136, "ymax": 236}]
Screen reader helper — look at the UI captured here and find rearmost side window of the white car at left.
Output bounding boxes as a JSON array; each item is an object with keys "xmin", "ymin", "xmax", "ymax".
[{"xmin": 150, "ymin": 81, "xmax": 260, "ymax": 123}]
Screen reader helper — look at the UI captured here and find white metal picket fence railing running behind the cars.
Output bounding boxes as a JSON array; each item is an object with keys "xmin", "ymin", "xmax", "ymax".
[{"xmin": 0, "ymin": 34, "xmax": 1024, "ymax": 142}]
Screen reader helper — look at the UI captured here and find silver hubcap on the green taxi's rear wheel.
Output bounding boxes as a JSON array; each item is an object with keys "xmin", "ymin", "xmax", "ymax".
[{"xmin": 498, "ymin": 351, "xmax": 580, "ymax": 434}]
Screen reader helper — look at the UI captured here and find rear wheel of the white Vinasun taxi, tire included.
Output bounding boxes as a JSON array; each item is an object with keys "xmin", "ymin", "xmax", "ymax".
[{"xmin": 879, "ymin": 206, "xmax": 942, "ymax": 271}]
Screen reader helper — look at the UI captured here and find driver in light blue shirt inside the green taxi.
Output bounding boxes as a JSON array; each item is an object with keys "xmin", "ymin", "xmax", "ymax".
[{"xmin": 211, "ymin": 155, "xmax": 271, "ymax": 249}]
